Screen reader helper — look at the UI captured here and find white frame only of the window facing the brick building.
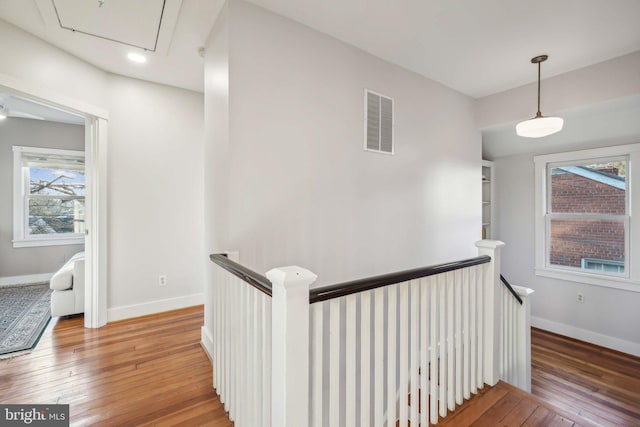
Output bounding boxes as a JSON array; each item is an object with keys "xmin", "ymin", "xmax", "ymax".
[{"xmin": 534, "ymin": 144, "xmax": 640, "ymax": 292}]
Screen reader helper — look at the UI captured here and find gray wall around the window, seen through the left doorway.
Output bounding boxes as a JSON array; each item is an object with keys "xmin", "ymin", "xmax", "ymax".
[{"xmin": 0, "ymin": 117, "xmax": 84, "ymax": 278}]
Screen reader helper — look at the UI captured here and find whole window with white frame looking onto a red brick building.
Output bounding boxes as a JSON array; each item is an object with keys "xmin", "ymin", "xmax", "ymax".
[{"xmin": 535, "ymin": 144, "xmax": 640, "ymax": 291}]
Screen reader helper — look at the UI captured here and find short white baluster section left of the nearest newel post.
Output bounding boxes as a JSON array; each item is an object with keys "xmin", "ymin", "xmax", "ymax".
[{"xmin": 208, "ymin": 254, "xmax": 275, "ymax": 426}]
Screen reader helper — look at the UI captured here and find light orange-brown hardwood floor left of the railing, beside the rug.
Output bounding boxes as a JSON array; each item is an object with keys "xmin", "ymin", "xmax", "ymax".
[{"xmin": 0, "ymin": 306, "xmax": 233, "ymax": 427}]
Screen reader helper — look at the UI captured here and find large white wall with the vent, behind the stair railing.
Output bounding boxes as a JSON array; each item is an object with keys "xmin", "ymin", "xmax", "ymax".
[{"xmin": 205, "ymin": 1, "xmax": 481, "ymax": 284}]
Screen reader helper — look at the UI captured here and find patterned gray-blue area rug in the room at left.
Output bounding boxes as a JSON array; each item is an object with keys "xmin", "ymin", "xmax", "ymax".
[{"xmin": 0, "ymin": 282, "xmax": 51, "ymax": 359}]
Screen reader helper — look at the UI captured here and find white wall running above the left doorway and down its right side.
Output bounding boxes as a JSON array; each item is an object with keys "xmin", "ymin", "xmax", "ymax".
[{"xmin": 0, "ymin": 21, "xmax": 204, "ymax": 320}]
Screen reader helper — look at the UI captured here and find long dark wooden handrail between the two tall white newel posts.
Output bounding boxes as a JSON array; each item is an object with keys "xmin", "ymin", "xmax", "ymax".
[{"xmin": 309, "ymin": 255, "xmax": 491, "ymax": 304}]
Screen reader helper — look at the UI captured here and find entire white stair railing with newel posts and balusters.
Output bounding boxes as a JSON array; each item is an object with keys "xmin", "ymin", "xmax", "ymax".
[{"xmin": 212, "ymin": 240, "xmax": 531, "ymax": 427}]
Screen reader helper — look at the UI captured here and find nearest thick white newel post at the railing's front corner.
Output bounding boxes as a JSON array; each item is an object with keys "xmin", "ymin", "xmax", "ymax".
[{"xmin": 267, "ymin": 266, "xmax": 317, "ymax": 427}]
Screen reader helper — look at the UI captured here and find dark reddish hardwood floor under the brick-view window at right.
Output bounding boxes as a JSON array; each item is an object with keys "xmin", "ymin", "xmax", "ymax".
[{"xmin": 531, "ymin": 328, "xmax": 640, "ymax": 427}]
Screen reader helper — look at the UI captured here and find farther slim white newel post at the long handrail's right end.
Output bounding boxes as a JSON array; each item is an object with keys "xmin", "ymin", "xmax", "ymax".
[{"xmin": 476, "ymin": 240, "xmax": 504, "ymax": 386}]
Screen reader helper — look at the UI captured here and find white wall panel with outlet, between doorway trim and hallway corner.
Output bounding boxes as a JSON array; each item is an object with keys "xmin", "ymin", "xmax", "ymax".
[{"xmin": 107, "ymin": 75, "xmax": 204, "ymax": 311}]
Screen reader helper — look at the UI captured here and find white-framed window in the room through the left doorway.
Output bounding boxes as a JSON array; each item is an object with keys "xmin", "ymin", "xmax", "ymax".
[{"xmin": 13, "ymin": 146, "xmax": 86, "ymax": 247}]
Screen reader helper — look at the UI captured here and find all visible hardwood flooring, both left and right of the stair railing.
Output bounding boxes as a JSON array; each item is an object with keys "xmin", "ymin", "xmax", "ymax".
[{"xmin": 0, "ymin": 306, "xmax": 640, "ymax": 427}]
